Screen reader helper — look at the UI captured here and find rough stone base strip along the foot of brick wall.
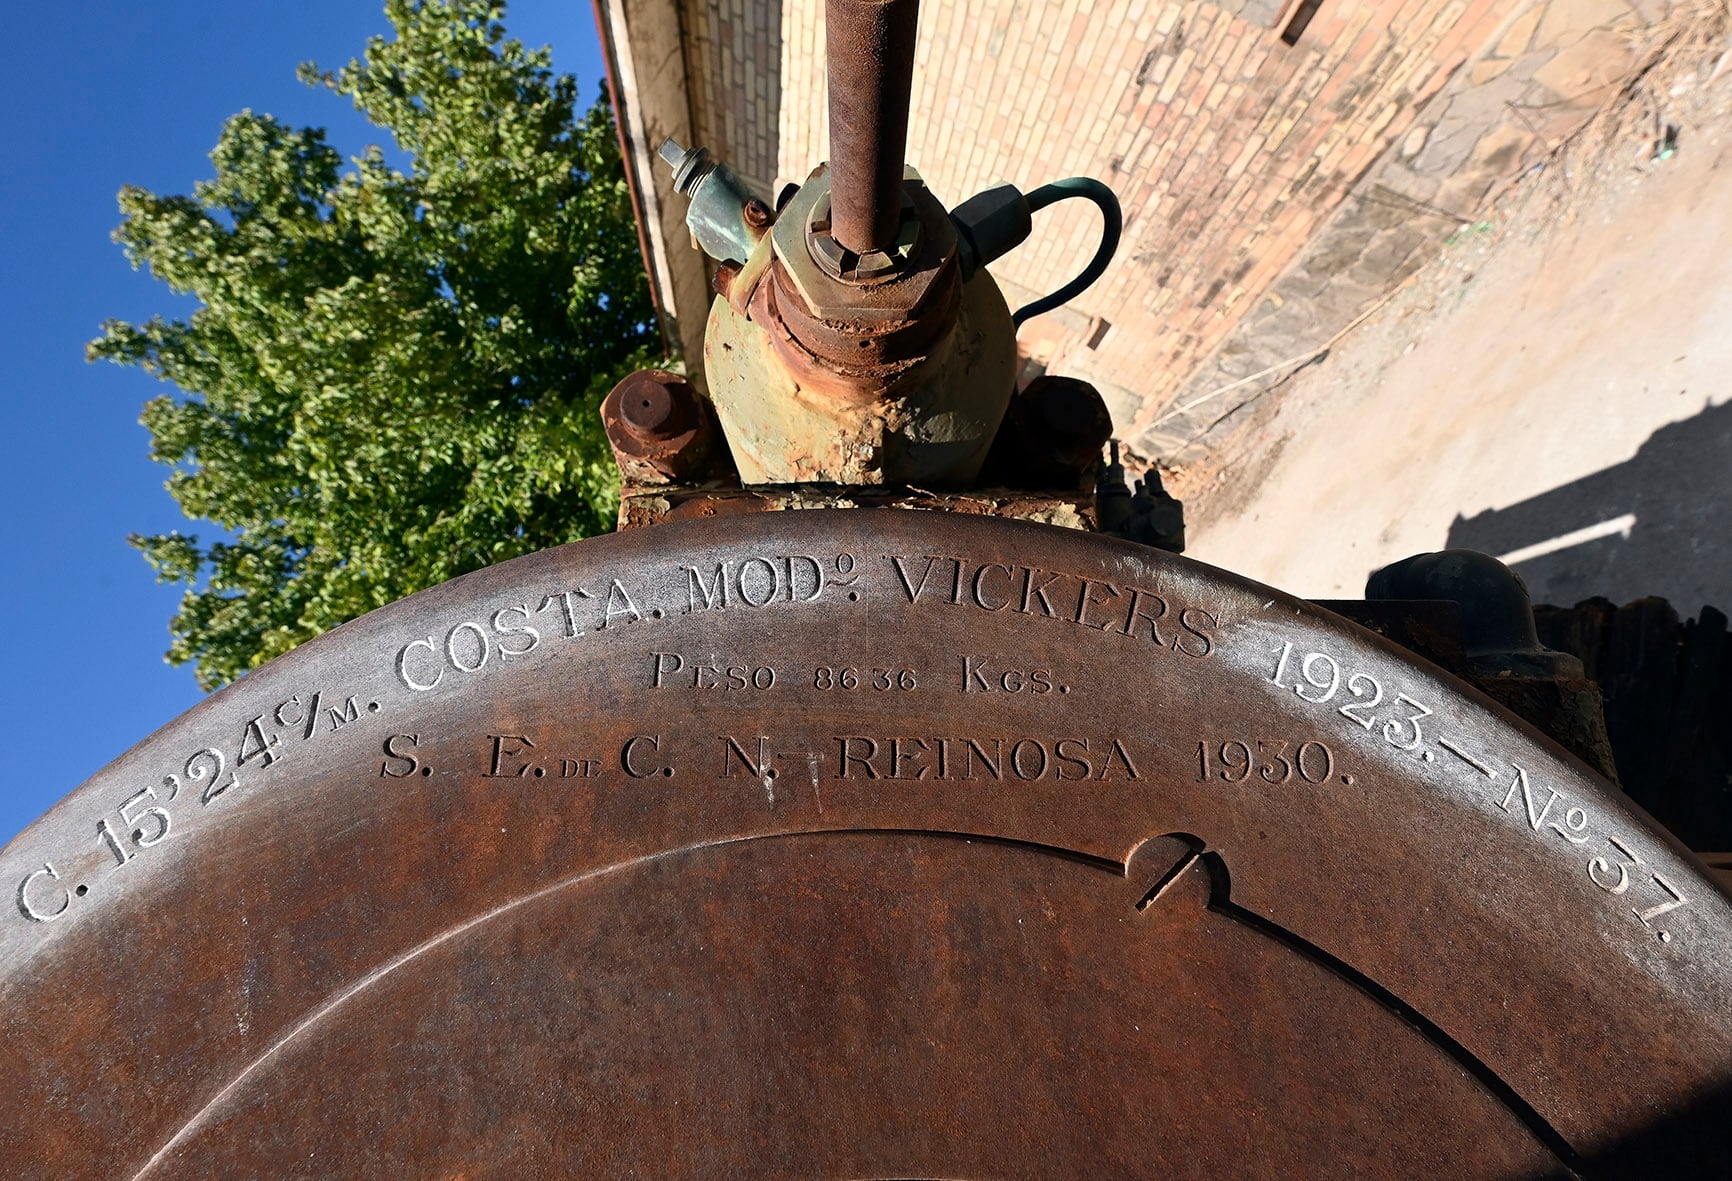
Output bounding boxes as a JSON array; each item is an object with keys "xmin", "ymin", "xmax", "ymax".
[{"xmin": 1136, "ymin": 0, "xmax": 1662, "ymax": 462}]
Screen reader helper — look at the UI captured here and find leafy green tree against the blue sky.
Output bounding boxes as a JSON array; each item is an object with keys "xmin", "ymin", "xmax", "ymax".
[{"xmin": 88, "ymin": 0, "xmax": 658, "ymax": 687}]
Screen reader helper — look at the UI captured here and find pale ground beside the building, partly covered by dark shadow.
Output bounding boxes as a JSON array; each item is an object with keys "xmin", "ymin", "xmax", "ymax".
[{"xmin": 1179, "ymin": 85, "xmax": 1732, "ymax": 615}]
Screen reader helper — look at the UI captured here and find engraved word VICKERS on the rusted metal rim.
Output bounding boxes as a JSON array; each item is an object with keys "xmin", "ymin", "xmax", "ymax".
[{"xmin": 889, "ymin": 554, "xmax": 1221, "ymax": 660}]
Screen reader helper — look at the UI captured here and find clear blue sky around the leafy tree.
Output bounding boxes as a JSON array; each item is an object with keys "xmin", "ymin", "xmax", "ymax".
[{"xmin": 0, "ymin": 0, "xmax": 601, "ymax": 843}]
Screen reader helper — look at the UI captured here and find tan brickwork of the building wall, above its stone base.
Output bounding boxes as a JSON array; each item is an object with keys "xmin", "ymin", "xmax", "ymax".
[{"xmin": 633, "ymin": 0, "xmax": 1640, "ymax": 450}]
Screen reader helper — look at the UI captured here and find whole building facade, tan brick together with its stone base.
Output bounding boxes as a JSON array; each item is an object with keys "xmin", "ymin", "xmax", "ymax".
[{"xmin": 598, "ymin": 0, "xmax": 1663, "ymax": 459}]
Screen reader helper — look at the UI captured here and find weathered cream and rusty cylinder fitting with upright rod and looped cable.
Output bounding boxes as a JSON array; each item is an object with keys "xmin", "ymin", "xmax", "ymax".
[{"xmin": 647, "ymin": 0, "xmax": 1119, "ymax": 492}]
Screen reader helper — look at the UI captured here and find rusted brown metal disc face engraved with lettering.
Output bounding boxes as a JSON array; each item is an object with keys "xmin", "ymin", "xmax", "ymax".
[{"xmin": 0, "ymin": 511, "xmax": 1732, "ymax": 1178}]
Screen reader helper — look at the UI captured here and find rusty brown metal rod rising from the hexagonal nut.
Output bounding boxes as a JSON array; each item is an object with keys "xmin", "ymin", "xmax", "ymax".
[{"xmin": 824, "ymin": 0, "xmax": 920, "ymax": 255}]
